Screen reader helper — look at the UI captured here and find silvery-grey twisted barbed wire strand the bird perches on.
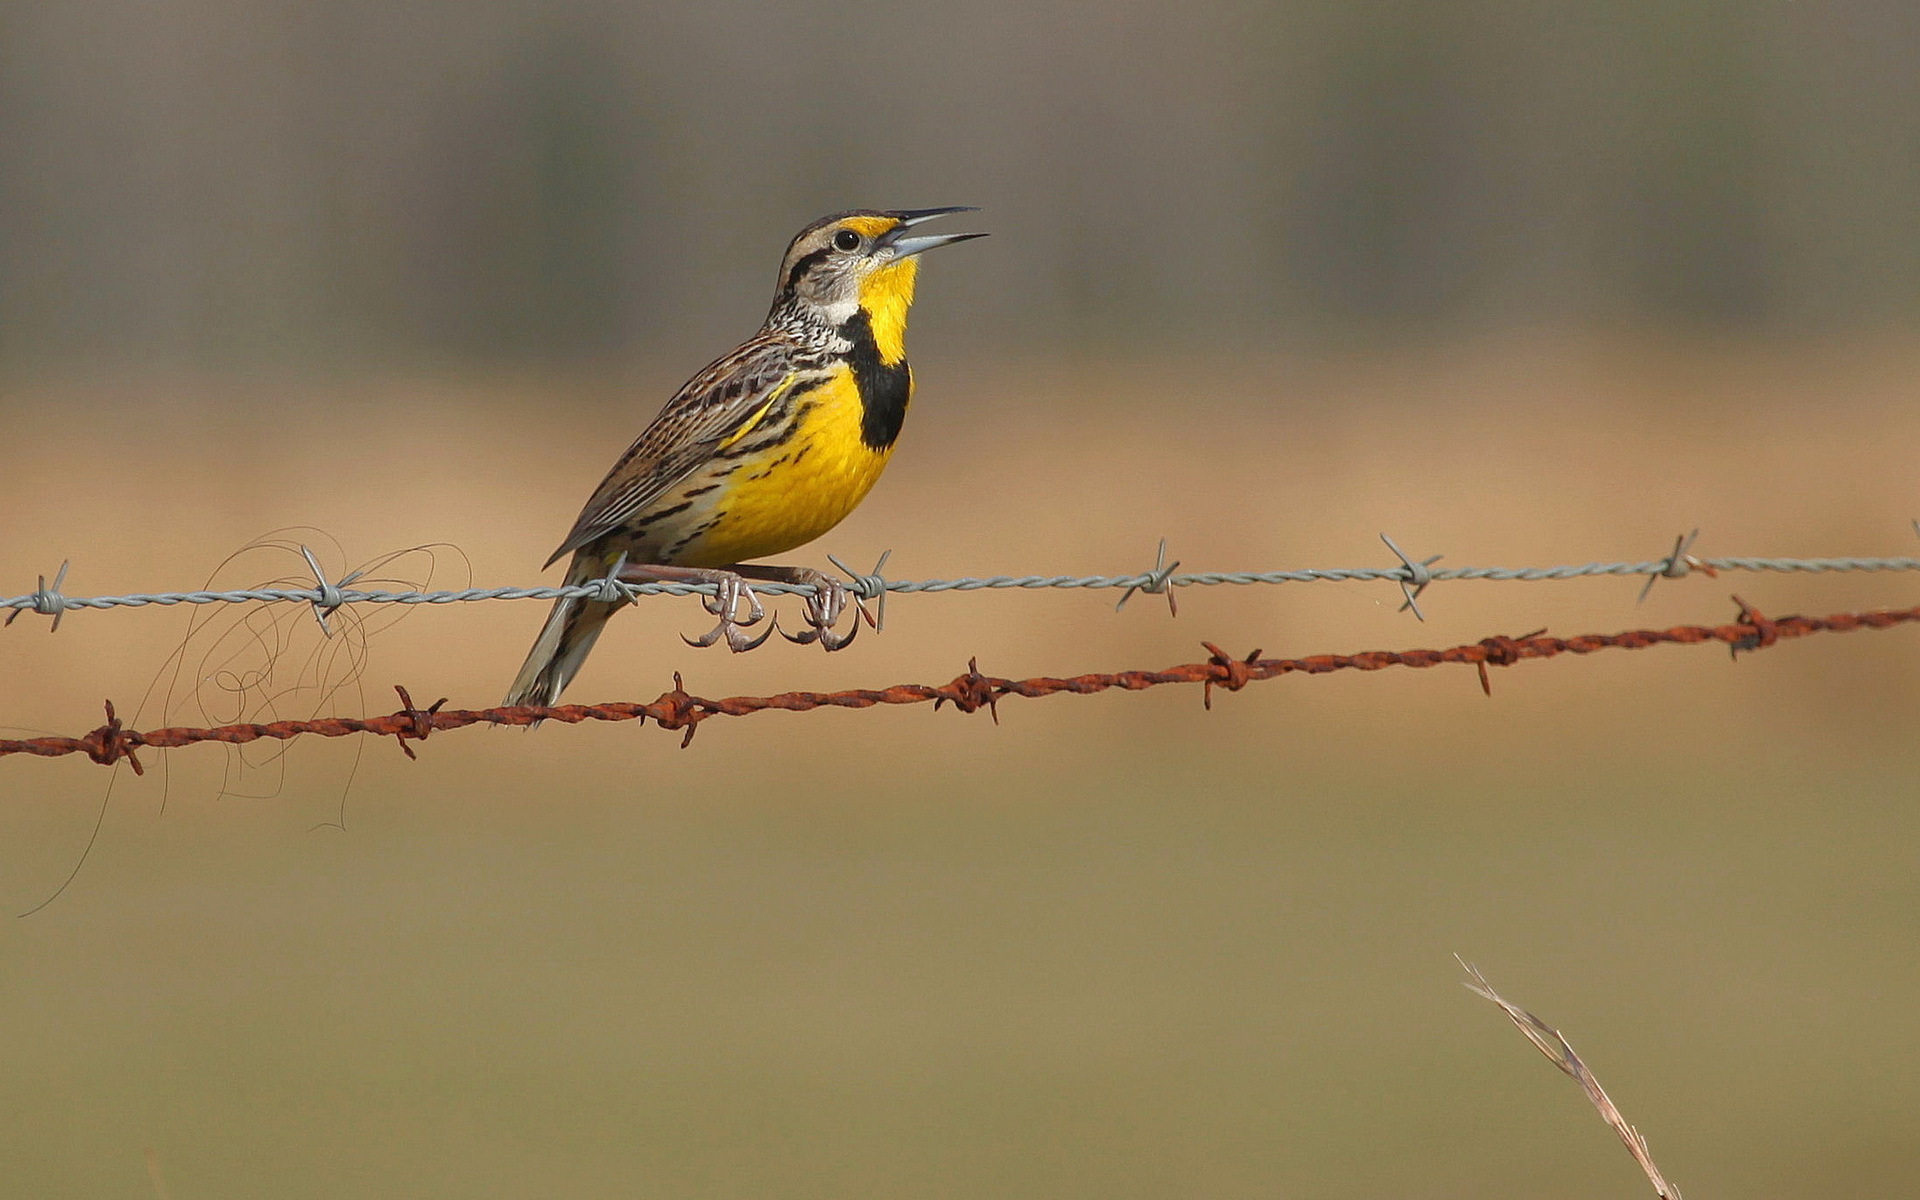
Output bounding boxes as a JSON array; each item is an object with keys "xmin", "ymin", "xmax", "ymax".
[{"xmin": 11, "ymin": 522, "xmax": 1920, "ymax": 630}]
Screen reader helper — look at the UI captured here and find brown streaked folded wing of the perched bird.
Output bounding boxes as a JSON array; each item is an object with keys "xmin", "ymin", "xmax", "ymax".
[{"xmin": 547, "ymin": 332, "xmax": 812, "ymax": 566}]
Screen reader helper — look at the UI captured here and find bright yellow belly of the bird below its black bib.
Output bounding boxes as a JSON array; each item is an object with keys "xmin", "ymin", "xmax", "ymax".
[{"xmin": 672, "ymin": 374, "xmax": 891, "ymax": 566}]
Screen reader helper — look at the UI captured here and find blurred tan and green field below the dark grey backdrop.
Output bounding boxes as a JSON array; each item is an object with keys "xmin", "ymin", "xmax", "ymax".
[{"xmin": 0, "ymin": 338, "xmax": 1920, "ymax": 1200}]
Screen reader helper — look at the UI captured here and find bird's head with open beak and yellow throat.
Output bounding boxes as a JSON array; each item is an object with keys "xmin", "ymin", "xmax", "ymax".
[{"xmin": 774, "ymin": 207, "xmax": 987, "ymax": 361}]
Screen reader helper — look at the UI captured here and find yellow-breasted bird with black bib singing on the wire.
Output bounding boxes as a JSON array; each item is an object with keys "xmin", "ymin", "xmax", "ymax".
[{"xmin": 505, "ymin": 207, "xmax": 985, "ymax": 705}]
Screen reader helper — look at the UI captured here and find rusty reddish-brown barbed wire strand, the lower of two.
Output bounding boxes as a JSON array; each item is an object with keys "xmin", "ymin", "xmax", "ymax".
[{"xmin": 0, "ymin": 595, "xmax": 1920, "ymax": 774}]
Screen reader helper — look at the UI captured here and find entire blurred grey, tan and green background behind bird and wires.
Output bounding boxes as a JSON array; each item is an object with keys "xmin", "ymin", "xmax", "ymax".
[{"xmin": 0, "ymin": 0, "xmax": 1920, "ymax": 1200}]
